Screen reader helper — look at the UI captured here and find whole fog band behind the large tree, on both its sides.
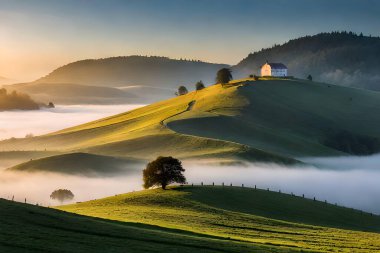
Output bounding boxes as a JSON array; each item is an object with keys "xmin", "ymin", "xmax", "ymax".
[{"xmin": 0, "ymin": 155, "xmax": 380, "ymax": 214}]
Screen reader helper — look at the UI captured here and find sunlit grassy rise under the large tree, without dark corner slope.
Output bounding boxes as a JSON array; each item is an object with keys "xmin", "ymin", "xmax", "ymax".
[{"xmin": 58, "ymin": 186, "xmax": 380, "ymax": 252}]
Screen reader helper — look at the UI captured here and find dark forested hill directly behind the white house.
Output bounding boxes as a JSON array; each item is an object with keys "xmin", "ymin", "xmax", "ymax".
[{"xmin": 233, "ymin": 32, "xmax": 380, "ymax": 90}]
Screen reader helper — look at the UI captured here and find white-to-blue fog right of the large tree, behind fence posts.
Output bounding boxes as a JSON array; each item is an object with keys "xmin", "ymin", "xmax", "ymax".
[{"xmin": 186, "ymin": 164, "xmax": 380, "ymax": 214}]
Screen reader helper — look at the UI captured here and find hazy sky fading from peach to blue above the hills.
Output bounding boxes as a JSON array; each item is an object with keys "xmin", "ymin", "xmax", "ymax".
[{"xmin": 0, "ymin": 0, "xmax": 380, "ymax": 81}]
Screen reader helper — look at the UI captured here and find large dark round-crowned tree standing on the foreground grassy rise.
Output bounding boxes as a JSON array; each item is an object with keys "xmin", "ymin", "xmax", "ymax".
[{"xmin": 143, "ymin": 156, "xmax": 186, "ymax": 190}]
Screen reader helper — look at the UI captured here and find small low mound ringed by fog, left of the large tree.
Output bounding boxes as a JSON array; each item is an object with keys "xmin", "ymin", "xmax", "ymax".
[{"xmin": 9, "ymin": 153, "xmax": 142, "ymax": 176}]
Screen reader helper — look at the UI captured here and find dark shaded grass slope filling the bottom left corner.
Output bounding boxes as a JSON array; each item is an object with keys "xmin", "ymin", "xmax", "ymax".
[{"xmin": 0, "ymin": 199, "xmax": 288, "ymax": 253}]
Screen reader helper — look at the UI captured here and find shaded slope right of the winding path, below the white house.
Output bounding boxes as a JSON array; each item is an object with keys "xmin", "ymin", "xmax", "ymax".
[{"xmin": 168, "ymin": 80, "xmax": 380, "ymax": 157}]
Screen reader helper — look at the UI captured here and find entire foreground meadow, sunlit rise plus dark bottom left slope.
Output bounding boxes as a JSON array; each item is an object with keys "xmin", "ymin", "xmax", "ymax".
[{"xmin": 0, "ymin": 186, "xmax": 380, "ymax": 253}]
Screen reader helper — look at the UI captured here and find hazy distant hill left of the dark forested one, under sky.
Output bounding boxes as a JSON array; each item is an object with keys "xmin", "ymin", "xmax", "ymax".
[{"xmin": 36, "ymin": 56, "xmax": 227, "ymax": 88}]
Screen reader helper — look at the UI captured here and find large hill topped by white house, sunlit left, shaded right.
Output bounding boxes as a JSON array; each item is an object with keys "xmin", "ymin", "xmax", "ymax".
[{"xmin": 0, "ymin": 79, "xmax": 380, "ymax": 172}]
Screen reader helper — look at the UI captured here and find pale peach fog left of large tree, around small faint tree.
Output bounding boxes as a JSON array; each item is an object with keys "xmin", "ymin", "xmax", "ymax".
[{"xmin": 0, "ymin": 171, "xmax": 142, "ymax": 206}]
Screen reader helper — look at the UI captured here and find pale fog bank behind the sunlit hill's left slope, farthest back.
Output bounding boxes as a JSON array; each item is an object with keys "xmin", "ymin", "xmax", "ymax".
[{"xmin": 0, "ymin": 105, "xmax": 143, "ymax": 140}]
